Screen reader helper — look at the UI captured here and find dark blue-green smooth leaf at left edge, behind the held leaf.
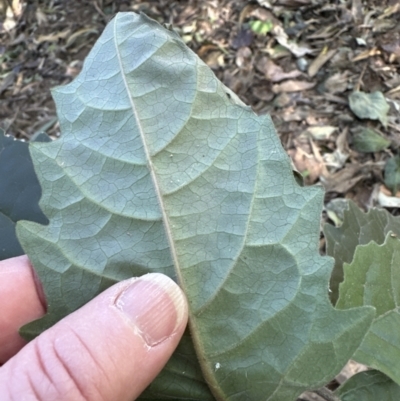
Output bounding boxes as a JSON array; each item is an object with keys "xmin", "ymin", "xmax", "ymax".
[{"xmin": 0, "ymin": 129, "xmax": 47, "ymax": 260}]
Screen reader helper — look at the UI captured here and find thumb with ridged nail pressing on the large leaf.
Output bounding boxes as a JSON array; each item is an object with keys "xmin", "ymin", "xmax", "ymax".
[{"xmin": 0, "ymin": 273, "xmax": 188, "ymax": 401}]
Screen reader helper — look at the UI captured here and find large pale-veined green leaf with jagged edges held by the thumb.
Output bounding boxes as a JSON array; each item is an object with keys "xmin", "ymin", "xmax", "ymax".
[{"xmin": 14, "ymin": 13, "xmax": 373, "ymax": 401}]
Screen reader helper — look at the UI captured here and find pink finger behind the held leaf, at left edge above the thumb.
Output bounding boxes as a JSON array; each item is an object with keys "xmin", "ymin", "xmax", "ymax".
[{"xmin": 0, "ymin": 255, "xmax": 45, "ymax": 365}]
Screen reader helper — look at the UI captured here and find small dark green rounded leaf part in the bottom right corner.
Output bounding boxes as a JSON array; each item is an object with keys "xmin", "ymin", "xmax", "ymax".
[{"xmin": 335, "ymin": 370, "xmax": 400, "ymax": 401}]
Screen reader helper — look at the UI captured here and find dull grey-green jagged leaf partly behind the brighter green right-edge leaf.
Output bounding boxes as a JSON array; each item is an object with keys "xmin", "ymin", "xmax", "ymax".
[{"xmin": 324, "ymin": 201, "xmax": 400, "ymax": 302}]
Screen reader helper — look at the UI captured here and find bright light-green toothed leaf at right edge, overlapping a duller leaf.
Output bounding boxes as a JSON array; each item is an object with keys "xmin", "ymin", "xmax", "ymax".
[{"xmin": 336, "ymin": 233, "xmax": 400, "ymax": 384}]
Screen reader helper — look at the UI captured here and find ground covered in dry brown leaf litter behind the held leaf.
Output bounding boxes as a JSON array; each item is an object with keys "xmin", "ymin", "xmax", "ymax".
[{"xmin": 0, "ymin": 0, "xmax": 400, "ymax": 399}]
